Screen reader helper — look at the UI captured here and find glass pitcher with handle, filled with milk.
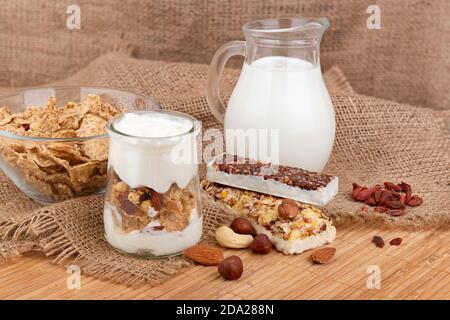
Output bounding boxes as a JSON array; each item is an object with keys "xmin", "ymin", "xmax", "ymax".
[{"xmin": 206, "ymin": 18, "xmax": 336, "ymax": 172}]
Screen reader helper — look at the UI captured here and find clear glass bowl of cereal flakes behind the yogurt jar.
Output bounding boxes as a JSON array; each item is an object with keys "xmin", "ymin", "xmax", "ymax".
[{"xmin": 0, "ymin": 86, "xmax": 160, "ymax": 203}]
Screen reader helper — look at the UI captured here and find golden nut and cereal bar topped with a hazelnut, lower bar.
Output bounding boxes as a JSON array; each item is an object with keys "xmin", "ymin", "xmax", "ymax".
[{"xmin": 201, "ymin": 180, "xmax": 336, "ymax": 254}]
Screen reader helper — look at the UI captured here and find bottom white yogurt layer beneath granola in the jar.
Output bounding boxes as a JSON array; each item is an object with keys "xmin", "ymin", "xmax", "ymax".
[{"xmin": 103, "ymin": 203, "xmax": 202, "ymax": 256}]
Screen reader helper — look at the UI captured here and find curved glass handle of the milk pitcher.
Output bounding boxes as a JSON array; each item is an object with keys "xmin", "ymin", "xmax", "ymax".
[{"xmin": 206, "ymin": 41, "xmax": 245, "ymax": 123}]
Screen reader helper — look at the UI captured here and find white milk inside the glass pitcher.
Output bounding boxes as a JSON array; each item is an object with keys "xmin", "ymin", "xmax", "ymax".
[{"xmin": 225, "ymin": 56, "xmax": 335, "ymax": 171}]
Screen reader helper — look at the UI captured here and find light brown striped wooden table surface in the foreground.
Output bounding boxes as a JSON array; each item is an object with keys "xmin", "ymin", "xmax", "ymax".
[{"xmin": 0, "ymin": 224, "xmax": 450, "ymax": 299}]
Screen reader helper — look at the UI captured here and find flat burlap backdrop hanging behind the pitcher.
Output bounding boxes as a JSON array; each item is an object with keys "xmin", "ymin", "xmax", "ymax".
[{"xmin": 0, "ymin": 0, "xmax": 450, "ymax": 109}]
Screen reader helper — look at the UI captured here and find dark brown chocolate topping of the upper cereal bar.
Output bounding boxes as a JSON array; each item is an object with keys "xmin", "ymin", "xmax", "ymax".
[{"xmin": 213, "ymin": 154, "xmax": 335, "ymax": 190}]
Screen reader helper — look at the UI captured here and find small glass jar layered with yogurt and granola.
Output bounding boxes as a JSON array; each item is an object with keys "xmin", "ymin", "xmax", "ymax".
[{"xmin": 104, "ymin": 110, "xmax": 202, "ymax": 257}]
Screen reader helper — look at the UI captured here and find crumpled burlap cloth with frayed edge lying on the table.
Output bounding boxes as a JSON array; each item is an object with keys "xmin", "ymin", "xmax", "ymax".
[{"xmin": 0, "ymin": 53, "xmax": 450, "ymax": 284}]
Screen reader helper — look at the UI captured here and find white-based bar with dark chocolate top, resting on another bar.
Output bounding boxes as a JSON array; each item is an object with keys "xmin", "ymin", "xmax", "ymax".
[{"xmin": 206, "ymin": 154, "xmax": 339, "ymax": 206}]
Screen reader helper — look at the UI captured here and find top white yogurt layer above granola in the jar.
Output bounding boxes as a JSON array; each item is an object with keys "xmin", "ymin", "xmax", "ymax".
[{"xmin": 108, "ymin": 111, "xmax": 199, "ymax": 193}]
